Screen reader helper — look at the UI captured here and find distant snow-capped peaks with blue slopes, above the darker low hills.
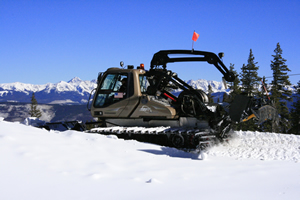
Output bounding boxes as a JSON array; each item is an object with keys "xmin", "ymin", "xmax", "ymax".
[{"xmin": 0, "ymin": 77, "xmax": 230, "ymax": 104}]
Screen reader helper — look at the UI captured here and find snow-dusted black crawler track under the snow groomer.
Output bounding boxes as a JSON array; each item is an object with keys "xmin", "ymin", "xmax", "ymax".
[{"xmin": 88, "ymin": 126, "xmax": 219, "ymax": 151}]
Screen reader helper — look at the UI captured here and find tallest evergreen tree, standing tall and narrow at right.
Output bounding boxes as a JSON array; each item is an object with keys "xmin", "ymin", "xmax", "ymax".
[{"xmin": 271, "ymin": 43, "xmax": 292, "ymax": 133}]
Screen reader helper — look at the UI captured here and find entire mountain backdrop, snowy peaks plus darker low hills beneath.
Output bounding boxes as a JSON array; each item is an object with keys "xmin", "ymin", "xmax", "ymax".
[{"xmin": 0, "ymin": 77, "xmax": 297, "ymax": 122}]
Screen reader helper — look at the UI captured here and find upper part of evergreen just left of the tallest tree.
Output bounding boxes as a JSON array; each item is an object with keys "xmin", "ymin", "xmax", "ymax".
[{"xmin": 241, "ymin": 49, "xmax": 261, "ymax": 96}]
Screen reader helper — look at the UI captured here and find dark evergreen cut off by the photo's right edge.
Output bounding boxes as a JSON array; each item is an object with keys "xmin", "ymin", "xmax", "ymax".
[{"xmin": 290, "ymin": 81, "xmax": 300, "ymax": 135}]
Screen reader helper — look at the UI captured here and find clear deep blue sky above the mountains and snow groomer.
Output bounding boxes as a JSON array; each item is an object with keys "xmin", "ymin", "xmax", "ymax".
[{"xmin": 0, "ymin": 0, "xmax": 300, "ymax": 84}]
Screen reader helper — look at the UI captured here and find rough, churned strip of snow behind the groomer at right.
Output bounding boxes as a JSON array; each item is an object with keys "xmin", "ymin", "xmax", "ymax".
[{"xmin": 209, "ymin": 131, "xmax": 300, "ymax": 162}]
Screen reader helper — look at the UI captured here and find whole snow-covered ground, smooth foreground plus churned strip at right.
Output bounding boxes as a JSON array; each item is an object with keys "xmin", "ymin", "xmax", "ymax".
[{"xmin": 0, "ymin": 118, "xmax": 300, "ymax": 200}]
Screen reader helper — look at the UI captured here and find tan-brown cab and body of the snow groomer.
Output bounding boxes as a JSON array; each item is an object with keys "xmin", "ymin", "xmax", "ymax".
[{"xmin": 91, "ymin": 66, "xmax": 176, "ymax": 126}]
